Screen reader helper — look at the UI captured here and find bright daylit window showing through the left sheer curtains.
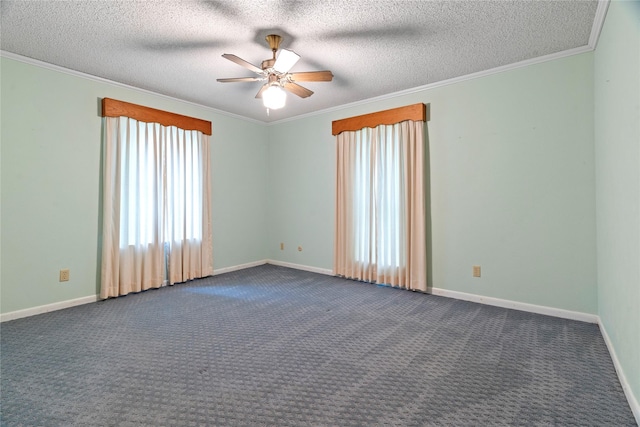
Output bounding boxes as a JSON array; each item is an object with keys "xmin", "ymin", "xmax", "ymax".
[{"xmin": 119, "ymin": 117, "xmax": 203, "ymax": 247}]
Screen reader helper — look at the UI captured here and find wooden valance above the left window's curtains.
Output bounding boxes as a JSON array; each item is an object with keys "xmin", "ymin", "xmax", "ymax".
[{"xmin": 102, "ymin": 98, "xmax": 211, "ymax": 135}]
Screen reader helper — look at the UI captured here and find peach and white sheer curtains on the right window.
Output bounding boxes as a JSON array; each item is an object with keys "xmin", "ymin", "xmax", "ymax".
[{"xmin": 334, "ymin": 121, "xmax": 427, "ymax": 291}]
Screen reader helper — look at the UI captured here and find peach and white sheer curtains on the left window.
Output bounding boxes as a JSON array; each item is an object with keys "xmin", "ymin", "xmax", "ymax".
[{"xmin": 100, "ymin": 117, "xmax": 213, "ymax": 298}]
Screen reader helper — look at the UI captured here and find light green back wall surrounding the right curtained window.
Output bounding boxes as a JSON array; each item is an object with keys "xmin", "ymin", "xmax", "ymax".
[{"xmin": 268, "ymin": 53, "xmax": 597, "ymax": 314}]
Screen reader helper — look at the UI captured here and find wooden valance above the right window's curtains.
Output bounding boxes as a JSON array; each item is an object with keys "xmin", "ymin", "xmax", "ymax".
[{"xmin": 332, "ymin": 103, "xmax": 429, "ymax": 135}]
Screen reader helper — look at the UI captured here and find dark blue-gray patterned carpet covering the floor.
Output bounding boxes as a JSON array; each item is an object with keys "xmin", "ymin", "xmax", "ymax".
[{"xmin": 0, "ymin": 265, "xmax": 635, "ymax": 426}]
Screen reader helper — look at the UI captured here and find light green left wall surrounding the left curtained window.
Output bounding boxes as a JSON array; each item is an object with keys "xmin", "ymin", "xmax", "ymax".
[{"xmin": 0, "ymin": 57, "xmax": 267, "ymax": 313}]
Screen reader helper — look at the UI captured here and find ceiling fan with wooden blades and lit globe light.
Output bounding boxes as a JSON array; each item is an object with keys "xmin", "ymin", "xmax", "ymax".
[{"xmin": 218, "ymin": 34, "xmax": 333, "ymax": 111}]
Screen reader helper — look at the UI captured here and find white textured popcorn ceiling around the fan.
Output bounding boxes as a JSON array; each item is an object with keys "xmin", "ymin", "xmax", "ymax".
[{"xmin": 0, "ymin": 0, "xmax": 597, "ymax": 122}]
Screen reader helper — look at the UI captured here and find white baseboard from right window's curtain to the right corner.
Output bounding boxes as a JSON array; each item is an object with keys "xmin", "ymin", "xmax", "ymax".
[{"xmin": 428, "ymin": 288, "xmax": 598, "ymax": 323}]
